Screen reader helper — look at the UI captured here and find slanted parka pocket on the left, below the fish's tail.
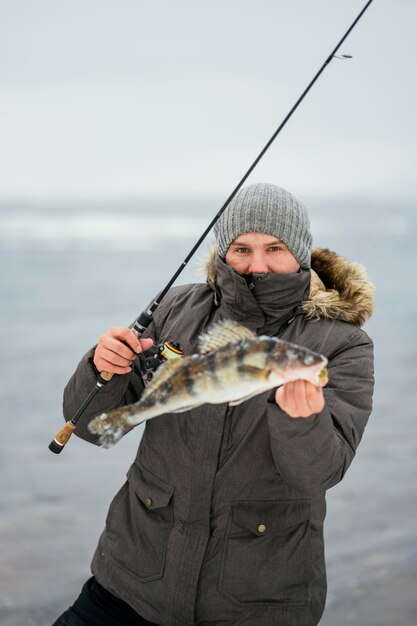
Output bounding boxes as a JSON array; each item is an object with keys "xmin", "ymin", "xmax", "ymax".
[{"xmin": 106, "ymin": 463, "xmax": 174, "ymax": 582}]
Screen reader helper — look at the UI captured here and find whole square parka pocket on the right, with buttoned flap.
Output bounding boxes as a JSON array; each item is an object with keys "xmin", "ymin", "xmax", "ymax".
[{"xmin": 219, "ymin": 500, "xmax": 312, "ymax": 607}]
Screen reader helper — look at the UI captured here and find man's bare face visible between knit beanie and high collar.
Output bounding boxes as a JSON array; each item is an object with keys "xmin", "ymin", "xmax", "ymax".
[{"xmin": 226, "ymin": 233, "xmax": 300, "ymax": 274}]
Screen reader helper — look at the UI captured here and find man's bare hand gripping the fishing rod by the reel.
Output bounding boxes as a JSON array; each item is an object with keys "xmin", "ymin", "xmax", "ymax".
[{"xmin": 93, "ymin": 328, "xmax": 153, "ymax": 374}]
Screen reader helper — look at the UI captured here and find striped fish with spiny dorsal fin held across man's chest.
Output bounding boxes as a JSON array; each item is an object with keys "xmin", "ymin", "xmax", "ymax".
[{"xmin": 88, "ymin": 320, "xmax": 328, "ymax": 448}]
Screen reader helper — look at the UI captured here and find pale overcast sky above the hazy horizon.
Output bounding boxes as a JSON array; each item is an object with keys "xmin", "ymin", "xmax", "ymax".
[{"xmin": 0, "ymin": 0, "xmax": 417, "ymax": 202}]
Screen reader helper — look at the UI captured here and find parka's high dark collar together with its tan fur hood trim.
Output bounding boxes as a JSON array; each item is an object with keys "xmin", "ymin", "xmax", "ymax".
[{"xmin": 206, "ymin": 247, "xmax": 375, "ymax": 333}]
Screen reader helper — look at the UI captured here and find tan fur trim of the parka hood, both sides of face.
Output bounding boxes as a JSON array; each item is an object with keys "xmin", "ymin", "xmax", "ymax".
[{"xmin": 205, "ymin": 246, "xmax": 375, "ymax": 326}]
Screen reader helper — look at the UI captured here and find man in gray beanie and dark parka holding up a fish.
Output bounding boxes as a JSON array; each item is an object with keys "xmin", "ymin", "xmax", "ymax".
[{"xmin": 55, "ymin": 184, "xmax": 373, "ymax": 626}]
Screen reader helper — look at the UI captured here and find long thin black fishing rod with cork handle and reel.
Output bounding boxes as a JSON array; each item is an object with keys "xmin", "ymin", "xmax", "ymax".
[{"xmin": 49, "ymin": 0, "xmax": 373, "ymax": 454}]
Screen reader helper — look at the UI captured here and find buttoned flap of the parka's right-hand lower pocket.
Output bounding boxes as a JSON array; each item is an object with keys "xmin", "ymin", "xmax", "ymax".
[{"xmin": 232, "ymin": 500, "xmax": 310, "ymax": 537}]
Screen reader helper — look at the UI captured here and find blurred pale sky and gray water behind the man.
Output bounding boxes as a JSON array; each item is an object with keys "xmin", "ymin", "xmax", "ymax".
[{"xmin": 0, "ymin": 0, "xmax": 417, "ymax": 626}]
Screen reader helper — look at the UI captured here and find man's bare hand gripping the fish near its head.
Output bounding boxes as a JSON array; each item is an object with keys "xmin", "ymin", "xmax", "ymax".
[{"xmin": 275, "ymin": 380, "xmax": 327, "ymax": 417}]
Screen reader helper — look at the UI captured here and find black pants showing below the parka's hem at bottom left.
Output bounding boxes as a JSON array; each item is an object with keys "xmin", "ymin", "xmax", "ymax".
[{"xmin": 52, "ymin": 577, "xmax": 158, "ymax": 626}]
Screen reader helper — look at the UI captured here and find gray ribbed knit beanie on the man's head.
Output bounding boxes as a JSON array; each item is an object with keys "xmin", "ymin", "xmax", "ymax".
[{"xmin": 214, "ymin": 183, "xmax": 312, "ymax": 269}]
